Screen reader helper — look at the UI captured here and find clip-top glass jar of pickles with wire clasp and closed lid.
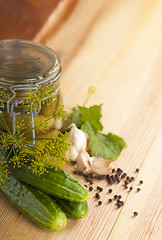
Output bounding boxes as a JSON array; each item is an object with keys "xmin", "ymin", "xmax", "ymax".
[{"xmin": 0, "ymin": 40, "xmax": 62, "ymax": 144}]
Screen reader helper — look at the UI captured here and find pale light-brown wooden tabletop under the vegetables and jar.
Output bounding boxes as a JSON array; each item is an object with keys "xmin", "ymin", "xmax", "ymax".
[{"xmin": 0, "ymin": 0, "xmax": 162, "ymax": 240}]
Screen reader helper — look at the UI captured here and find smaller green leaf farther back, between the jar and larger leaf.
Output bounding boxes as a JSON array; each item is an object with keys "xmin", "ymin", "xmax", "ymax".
[{"xmin": 71, "ymin": 104, "xmax": 103, "ymax": 131}]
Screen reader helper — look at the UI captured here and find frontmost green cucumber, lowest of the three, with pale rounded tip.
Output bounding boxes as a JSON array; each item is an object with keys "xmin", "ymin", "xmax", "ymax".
[{"xmin": 0, "ymin": 175, "xmax": 67, "ymax": 231}]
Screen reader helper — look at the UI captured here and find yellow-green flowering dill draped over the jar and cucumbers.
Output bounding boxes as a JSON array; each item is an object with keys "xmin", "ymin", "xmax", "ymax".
[{"xmin": 0, "ymin": 86, "xmax": 71, "ymax": 185}]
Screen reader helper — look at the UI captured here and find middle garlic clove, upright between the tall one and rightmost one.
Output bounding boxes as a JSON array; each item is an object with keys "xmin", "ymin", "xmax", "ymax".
[{"xmin": 76, "ymin": 150, "xmax": 91, "ymax": 172}]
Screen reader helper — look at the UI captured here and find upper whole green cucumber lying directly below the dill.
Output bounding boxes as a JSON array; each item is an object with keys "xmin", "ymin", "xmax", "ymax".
[{"xmin": 9, "ymin": 159, "xmax": 89, "ymax": 202}]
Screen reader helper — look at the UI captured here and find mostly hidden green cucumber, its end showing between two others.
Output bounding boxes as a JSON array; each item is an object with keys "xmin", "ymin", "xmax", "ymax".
[{"xmin": 55, "ymin": 198, "xmax": 88, "ymax": 219}]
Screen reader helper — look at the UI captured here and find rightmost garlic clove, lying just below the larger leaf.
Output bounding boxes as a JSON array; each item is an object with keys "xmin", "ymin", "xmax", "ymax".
[{"xmin": 89, "ymin": 156, "xmax": 110, "ymax": 175}]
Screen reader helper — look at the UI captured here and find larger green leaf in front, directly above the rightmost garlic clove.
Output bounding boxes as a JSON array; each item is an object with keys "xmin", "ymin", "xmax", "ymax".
[{"xmin": 81, "ymin": 122, "xmax": 127, "ymax": 160}]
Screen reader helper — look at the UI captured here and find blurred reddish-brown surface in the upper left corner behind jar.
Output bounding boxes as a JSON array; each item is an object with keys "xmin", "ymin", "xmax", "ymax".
[{"xmin": 0, "ymin": 0, "xmax": 77, "ymax": 40}]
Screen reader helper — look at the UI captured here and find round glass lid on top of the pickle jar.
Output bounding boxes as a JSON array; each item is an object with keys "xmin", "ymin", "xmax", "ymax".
[{"xmin": 0, "ymin": 39, "xmax": 61, "ymax": 86}]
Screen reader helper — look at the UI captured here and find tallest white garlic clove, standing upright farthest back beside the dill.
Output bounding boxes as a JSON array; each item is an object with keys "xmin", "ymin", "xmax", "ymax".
[{"xmin": 69, "ymin": 123, "xmax": 87, "ymax": 152}]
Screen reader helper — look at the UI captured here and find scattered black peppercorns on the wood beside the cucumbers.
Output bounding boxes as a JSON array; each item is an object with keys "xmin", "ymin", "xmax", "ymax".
[{"xmin": 74, "ymin": 168, "xmax": 143, "ymax": 216}]
